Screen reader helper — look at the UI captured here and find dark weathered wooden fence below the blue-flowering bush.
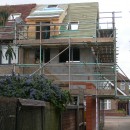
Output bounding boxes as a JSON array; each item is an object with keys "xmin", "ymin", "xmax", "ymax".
[{"xmin": 0, "ymin": 97, "xmax": 84, "ymax": 130}]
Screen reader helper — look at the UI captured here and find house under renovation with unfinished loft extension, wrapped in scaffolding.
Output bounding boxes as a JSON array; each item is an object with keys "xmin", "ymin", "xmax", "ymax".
[{"xmin": 0, "ymin": 2, "xmax": 128, "ymax": 130}]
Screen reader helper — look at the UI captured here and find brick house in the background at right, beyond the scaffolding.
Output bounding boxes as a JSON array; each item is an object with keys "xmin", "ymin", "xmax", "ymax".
[{"xmin": 104, "ymin": 72, "xmax": 130, "ymax": 116}]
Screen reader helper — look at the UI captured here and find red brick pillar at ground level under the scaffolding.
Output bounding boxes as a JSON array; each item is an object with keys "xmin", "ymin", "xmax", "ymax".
[{"xmin": 86, "ymin": 96, "xmax": 96, "ymax": 130}]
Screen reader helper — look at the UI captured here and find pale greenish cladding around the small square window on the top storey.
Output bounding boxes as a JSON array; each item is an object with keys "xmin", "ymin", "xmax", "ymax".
[{"xmin": 61, "ymin": 2, "xmax": 98, "ymax": 37}]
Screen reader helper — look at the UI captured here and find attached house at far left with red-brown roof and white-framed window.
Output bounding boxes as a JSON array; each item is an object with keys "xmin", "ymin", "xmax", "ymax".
[{"xmin": 0, "ymin": 4, "xmax": 36, "ymax": 76}]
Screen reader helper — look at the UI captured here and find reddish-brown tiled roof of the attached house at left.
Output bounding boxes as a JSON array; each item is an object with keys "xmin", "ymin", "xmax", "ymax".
[{"xmin": 0, "ymin": 4, "xmax": 36, "ymax": 40}]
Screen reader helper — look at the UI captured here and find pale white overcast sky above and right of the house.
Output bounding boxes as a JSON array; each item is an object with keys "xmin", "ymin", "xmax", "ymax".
[{"xmin": 0, "ymin": 0, "xmax": 130, "ymax": 78}]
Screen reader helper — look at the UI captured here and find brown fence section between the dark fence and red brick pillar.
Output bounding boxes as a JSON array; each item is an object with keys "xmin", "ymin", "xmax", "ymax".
[{"xmin": 61, "ymin": 105, "xmax": 84, "ymax": 130}]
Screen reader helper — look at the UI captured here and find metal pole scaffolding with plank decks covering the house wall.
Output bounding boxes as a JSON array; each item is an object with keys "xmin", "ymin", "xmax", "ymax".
[{"xmin": 0, "ymin": 8, "xmax": 128, "ymax": 98}]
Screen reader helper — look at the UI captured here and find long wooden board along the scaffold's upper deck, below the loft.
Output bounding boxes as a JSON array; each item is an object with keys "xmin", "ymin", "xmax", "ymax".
[{"xmin": 17, "ymin": 38, "xmax": 113, "ymax": 45}]
